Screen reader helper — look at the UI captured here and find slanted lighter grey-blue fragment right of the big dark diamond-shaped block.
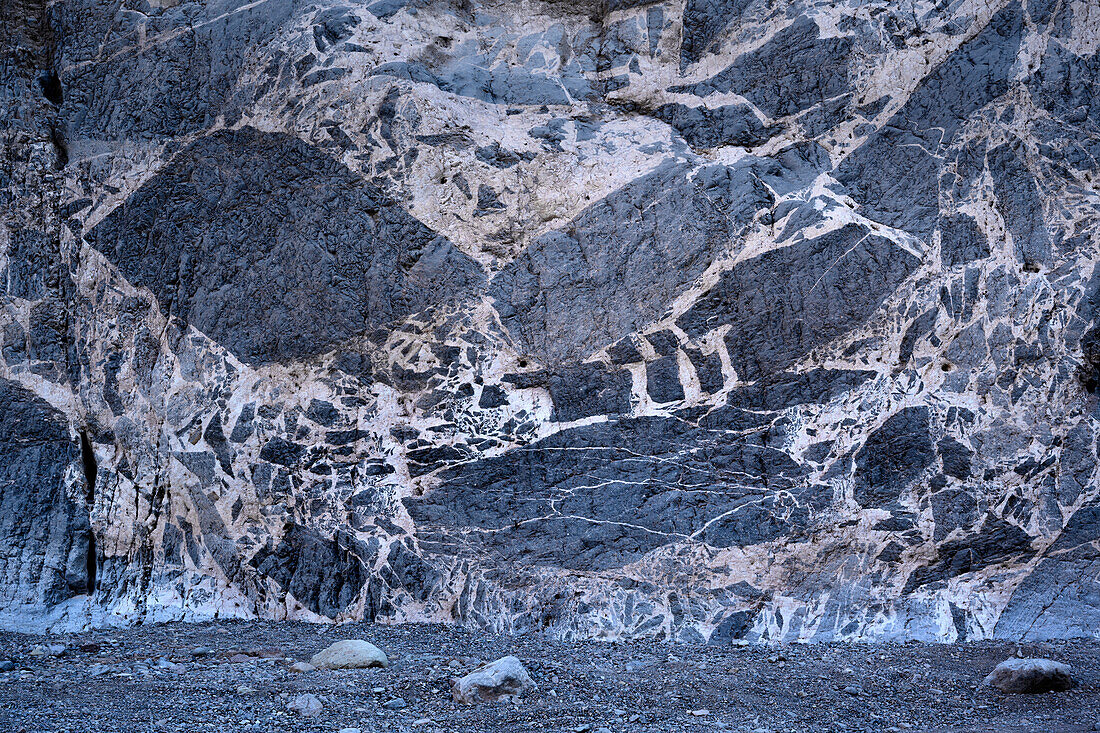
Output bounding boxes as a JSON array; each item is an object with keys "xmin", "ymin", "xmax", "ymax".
[{"xmin": 490, "ymin": 164, "xmax": 767, "ymax": 364}]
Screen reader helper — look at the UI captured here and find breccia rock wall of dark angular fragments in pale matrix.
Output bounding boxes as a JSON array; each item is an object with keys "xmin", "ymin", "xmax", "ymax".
[{"xmin": 0, "ymin": 0, "xmax": 1100, "ymax": 643}]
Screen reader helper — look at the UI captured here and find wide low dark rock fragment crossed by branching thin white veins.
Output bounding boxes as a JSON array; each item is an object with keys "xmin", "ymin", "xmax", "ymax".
[{"xmin": 405, "ymin": 414, "xmax": 809, "ymax": 569}]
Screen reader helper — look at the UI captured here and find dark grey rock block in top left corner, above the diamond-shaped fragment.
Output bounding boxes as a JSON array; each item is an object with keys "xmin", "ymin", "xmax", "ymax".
[{"xmin": 52, "ymin": 0, "xmax": 294, "ymax": 140}]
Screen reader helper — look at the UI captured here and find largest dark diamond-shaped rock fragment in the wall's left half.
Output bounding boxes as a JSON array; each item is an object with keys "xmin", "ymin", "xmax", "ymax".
[{"xmin": 88, "ymin": 128, "xmax": 482, "ymax": 363}]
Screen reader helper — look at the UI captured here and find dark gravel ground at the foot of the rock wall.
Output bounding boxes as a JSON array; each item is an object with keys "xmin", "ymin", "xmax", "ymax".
[{"xmin": 0, "ymin": 622, "xmax": 1100, "ymax": 733}]
